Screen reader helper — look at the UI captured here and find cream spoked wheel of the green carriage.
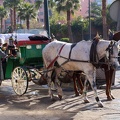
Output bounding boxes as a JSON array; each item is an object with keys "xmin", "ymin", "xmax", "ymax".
[{"xmin": 11, "ymin": 67, "xmax": 28, "ymax": 95}]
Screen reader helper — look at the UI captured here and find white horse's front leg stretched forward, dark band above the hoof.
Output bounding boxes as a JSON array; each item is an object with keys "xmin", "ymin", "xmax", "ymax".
[{"xmin": 86, "ymin": 68, "xmax": 103, "ymax": 107}]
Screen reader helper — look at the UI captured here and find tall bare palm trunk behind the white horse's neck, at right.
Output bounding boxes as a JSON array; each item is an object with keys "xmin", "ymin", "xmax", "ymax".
[{"xmin": 102, "ymin": 0, "xmax": 108, "ymax": 39}]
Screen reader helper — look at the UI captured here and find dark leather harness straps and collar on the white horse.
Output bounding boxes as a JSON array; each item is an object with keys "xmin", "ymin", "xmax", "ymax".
[{"xmin": 47, "ymin": 40, "xmax": 118, "ymax": 69}]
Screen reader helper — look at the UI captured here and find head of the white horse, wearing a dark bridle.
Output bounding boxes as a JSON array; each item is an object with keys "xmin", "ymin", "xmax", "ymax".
[{"xmin": 106, "ymin": 41, "xmax": 120, "ymax": 69}]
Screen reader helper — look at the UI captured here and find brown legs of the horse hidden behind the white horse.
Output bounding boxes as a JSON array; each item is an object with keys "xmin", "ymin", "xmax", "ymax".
[{"xmin": 73, "ymin": 64, "xmax": 115, "ymax": 100}]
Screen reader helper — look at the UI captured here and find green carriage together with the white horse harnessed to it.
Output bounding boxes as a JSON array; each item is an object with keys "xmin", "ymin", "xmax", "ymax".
[{"xmin": 1, "ymin": 30, "xmax": 120, "ymax": 107}]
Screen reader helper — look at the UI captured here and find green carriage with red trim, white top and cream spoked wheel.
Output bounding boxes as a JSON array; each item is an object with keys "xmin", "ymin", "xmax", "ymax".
[{"xmin": 1, "ymin": 28, "xmax": 49, "ymax": 95}]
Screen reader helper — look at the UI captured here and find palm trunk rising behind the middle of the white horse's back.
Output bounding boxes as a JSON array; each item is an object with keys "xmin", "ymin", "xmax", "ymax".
[{"xmin": 67, "ymin": 10, "xmax": 74, "ymax": 42}]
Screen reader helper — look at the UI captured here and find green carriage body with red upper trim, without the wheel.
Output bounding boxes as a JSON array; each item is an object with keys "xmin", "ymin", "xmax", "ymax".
[{"xmin": 5, "ymin": 40, "xmax": 48, "ymax": 79}]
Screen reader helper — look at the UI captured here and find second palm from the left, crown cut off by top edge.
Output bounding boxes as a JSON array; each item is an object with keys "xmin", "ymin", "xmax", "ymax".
[{"xmin": 3, "ymin": 0, "xmax": 23, "ymax": 30}]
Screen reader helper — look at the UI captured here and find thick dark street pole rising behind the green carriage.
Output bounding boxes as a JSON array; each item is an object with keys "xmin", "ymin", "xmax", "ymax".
[{"xmin": 44, "ymin": 0, "xmax": 50, "ymax": 38}]
